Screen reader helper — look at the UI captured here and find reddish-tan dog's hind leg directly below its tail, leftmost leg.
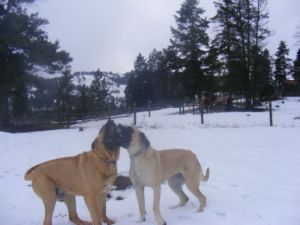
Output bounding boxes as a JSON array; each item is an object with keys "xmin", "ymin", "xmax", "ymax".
[{"xmin": 32, "ymin": 174, "xmax": 56, "ymax": 225}]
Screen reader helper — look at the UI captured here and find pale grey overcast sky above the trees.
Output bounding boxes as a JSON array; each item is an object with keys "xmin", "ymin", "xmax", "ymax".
[{"xmin": 32, "ymin": 0, "xmax": 300, "ymax": 73}]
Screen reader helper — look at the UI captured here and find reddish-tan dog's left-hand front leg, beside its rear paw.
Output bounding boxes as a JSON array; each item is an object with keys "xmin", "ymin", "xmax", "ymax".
[{"xmin": 84, "ymin": 196, "xmax": 102, "ymax": 225}]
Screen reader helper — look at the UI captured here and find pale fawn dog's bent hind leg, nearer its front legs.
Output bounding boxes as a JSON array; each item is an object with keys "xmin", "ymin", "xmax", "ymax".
[{"xmin": 168, "ymin": 173, "xmax": 189, "ymax": 209}]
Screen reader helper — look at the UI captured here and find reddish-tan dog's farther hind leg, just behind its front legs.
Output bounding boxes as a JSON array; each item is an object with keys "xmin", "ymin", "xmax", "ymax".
[{"xmin": 63, "ymin": 194, "xmax": 92, "ymax": 225}]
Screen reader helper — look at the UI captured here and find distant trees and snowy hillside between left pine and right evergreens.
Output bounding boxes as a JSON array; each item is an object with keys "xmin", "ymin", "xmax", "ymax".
[{"xmin": 28, "ymin": 70, "xmax": 125, "ymax": 120}]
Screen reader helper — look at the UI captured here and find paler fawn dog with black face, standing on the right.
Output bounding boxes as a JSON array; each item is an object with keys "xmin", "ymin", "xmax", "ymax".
[{"xmin": 118, "ymin": 124, "xmax": 209, "ymax": 225}]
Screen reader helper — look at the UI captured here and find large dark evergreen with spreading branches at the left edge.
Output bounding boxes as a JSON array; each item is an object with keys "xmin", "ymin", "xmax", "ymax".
[{"xmin": 0, "ymin": 0, "xmax": 71, "ymax": 127}]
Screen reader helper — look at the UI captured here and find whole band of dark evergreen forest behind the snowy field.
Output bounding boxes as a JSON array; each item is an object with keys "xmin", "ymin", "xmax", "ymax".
[{"xmin": 0, "ymin": 0, "xmax": 300, "ymax": 129}]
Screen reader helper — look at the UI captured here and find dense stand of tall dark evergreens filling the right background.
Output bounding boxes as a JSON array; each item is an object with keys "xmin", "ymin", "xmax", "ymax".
[{"xmin": 125, "ymin": 0, "xmax": 300, "ymax": 108}]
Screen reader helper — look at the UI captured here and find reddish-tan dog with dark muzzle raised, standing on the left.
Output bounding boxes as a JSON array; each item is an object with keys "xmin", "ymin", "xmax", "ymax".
[{"xmin": 25, "ymin": 120, "xmax": 120, "ymax": 225}]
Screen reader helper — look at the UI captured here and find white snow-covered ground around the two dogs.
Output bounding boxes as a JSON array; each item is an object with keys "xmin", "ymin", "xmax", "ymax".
[{"xmin": 0, "ymin": 97, "xmax": 300, "ymax": 225}]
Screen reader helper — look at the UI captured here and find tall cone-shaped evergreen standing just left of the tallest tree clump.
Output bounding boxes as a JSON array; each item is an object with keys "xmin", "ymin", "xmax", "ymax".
[{"xmin": 171, "ymin": 0, "xmax": 209, "ymax": 97}]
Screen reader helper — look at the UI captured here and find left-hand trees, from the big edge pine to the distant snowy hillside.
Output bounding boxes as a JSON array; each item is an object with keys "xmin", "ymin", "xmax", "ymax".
[{"xmin": 0, "ymin": 0, "xmax": 126, "ymax": 129}]
